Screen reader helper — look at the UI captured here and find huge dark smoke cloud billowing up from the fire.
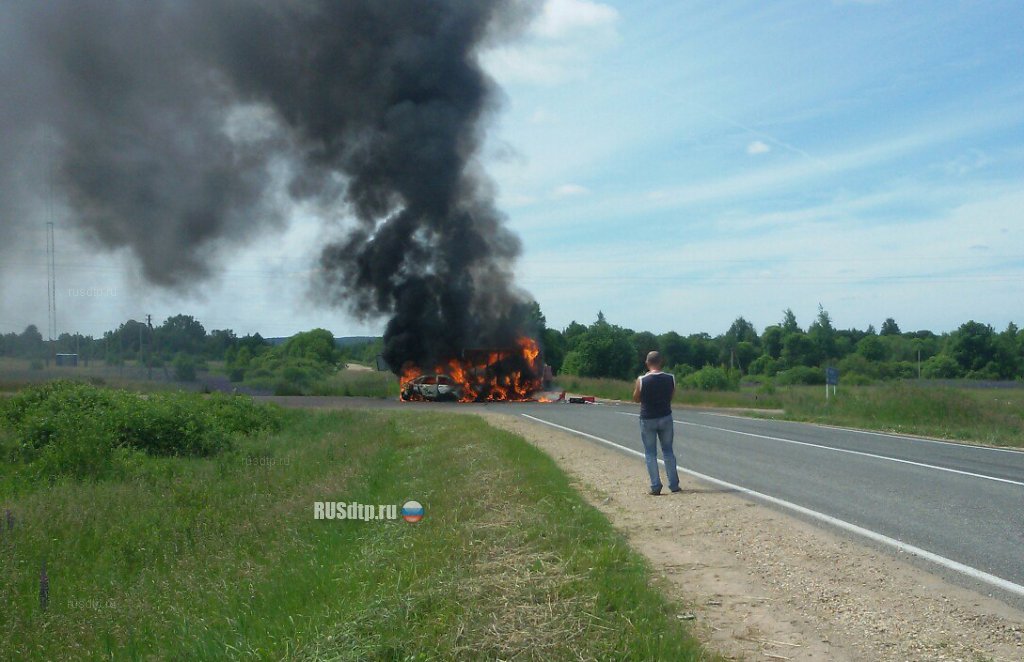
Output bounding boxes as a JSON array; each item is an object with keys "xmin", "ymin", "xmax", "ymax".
[{"xmin": 0, "ymin": 0, "xmax": 531, "ymax": 367}]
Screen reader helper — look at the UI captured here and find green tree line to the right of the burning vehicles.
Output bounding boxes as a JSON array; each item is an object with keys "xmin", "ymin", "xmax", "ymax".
[{"xmin": 536, "ymin": 306, "xmax": 1024, "ymax": 386}]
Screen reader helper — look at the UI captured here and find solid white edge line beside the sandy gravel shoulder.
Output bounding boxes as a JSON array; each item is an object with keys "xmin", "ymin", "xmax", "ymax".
[{"xmin": 522, "ymin": 414, "xmax": 1024, "ymax": 597}]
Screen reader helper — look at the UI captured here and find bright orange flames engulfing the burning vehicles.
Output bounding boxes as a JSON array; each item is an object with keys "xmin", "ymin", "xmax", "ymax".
[{"xmin": 399, "ymin": 336, "xmax": 544, "ymax": 403}]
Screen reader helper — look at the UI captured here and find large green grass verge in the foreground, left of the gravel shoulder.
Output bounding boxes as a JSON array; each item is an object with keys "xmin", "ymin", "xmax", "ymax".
[{"xmin": 0, "ymin": 411, "xmax": 709, "ymax": 660}]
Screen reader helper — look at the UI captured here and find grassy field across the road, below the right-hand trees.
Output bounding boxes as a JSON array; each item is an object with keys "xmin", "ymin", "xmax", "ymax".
[{"xmin": 558, "ymin": 377, "xmax": 1024, "ymax": 448}]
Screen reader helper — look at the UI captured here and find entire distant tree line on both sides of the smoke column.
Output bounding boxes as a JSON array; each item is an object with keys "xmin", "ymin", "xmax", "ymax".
[{"xmin": 0, "ymin": 302, "xmax": 1024, "ymax": 387}]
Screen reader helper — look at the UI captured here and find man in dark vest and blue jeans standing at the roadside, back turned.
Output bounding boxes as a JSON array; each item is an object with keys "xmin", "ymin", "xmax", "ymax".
[{"xmin": 633, "ymin": 351, "xmax": 679, "ymax": 496}]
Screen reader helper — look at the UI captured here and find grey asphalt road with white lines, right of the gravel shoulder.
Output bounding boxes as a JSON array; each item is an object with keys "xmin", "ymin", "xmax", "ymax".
[{"xmin": 489, "ymin": 404, "xmax": 1024, "ymax": 607}]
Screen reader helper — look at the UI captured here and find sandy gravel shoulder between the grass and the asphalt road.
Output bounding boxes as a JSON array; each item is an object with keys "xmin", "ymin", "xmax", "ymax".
[{"xmin": 481, "ymin": 412, "xmax": 1024, "ymax": 662}]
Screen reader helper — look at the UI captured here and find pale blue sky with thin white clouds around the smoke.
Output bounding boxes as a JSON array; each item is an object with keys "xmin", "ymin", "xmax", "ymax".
[{"xmin": 8, "ymin": 0, "xmax": 1024, "ymax": 335}]
